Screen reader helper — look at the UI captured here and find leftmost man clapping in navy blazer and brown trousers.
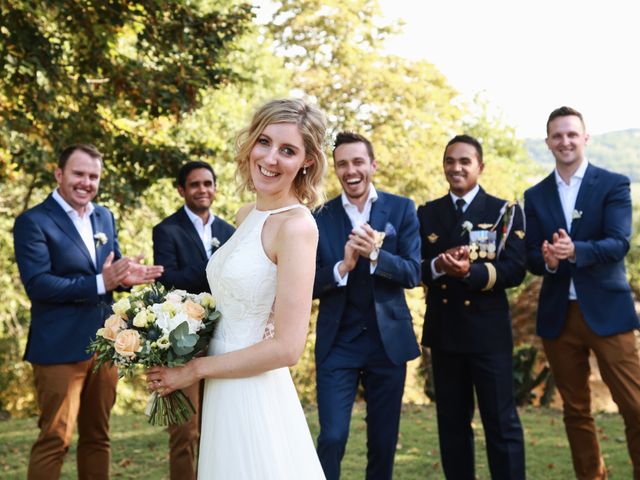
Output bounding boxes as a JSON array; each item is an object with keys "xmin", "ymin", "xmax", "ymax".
[{"xmin": 13, "ymin": 144, "xmax": 162, "ymax": 479}]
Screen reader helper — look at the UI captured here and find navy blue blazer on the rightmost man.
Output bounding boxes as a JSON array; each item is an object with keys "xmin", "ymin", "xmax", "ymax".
[{"xmin": 524, "ymin": 164, "xmax": 640, "ymax": 338}]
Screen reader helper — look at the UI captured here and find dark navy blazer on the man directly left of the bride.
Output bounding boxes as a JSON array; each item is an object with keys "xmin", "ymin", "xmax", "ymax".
[{"xmin": 153, "ymin": 207, "xmax": 235, "ymax": 293}]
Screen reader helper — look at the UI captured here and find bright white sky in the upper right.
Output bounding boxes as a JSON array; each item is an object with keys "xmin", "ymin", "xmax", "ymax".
[{"xmin": 380, "ymin": 0, "xmax": 640, "ymax": 138}]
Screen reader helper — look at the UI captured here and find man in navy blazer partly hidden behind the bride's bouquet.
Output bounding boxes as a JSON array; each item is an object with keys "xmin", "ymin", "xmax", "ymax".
[{"xmin": 153, "ymin": 161, "xmax": 235, "ymax": 480}]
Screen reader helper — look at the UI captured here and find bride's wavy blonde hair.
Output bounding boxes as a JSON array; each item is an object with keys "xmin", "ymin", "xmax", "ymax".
[{"xmin": 236, "ymin": 98, "xmax": 327, "ymax": 208}]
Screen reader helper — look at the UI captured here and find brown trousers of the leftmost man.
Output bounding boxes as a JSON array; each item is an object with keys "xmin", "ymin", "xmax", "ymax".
[{"xmin": 27, "ymin": 357, "xmax": 118, "ymax": 480}]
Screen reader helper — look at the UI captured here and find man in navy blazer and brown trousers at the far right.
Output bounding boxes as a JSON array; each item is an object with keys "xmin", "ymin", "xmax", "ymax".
[{"xmin": 524, "ymin": 107, "xmax": 640, "ymax": 479}]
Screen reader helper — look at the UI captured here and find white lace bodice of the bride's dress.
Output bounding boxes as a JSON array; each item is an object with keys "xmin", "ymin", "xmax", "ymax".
[{"xmin": 207, "ymin": 205, "xmax": 305, "ymax": 354}]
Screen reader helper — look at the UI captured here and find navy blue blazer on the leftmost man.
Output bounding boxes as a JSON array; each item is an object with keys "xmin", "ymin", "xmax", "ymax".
[{"xmin": 13, "ymin": 195, "xmax": 121, "ymax": 364}]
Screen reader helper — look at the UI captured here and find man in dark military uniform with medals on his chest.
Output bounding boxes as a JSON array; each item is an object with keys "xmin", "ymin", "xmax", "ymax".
[{"xmin": 418, "ymin": 135, "xmax": 525, "ymax": 480}]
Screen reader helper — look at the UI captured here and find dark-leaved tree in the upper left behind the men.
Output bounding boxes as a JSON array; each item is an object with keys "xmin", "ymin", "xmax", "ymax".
[{"xmin": 0, "ymin": 0, "xmax": 252, "ymax": 207}]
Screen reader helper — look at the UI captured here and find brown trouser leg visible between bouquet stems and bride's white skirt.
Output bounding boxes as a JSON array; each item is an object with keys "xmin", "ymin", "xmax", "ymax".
[{"xmin": 168, "ymin": 382, "xmax": 202, "ymax": 480}]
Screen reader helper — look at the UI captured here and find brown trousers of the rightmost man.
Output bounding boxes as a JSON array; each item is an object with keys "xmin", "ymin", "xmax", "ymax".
[{"xmin": 542, "ymin": 301, "xmax": 640, "ymax": 480}]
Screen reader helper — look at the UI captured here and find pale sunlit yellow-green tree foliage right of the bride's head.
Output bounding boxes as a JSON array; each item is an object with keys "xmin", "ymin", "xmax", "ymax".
[{"xmin": 270, "ymin": 0, "xmax": 528, "ymax": 203}]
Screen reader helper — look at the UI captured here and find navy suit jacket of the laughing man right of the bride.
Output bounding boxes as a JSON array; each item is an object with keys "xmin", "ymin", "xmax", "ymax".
[{"xmin": 313, "ymin": 191, "xmax": 420, "ymax": 364}]
